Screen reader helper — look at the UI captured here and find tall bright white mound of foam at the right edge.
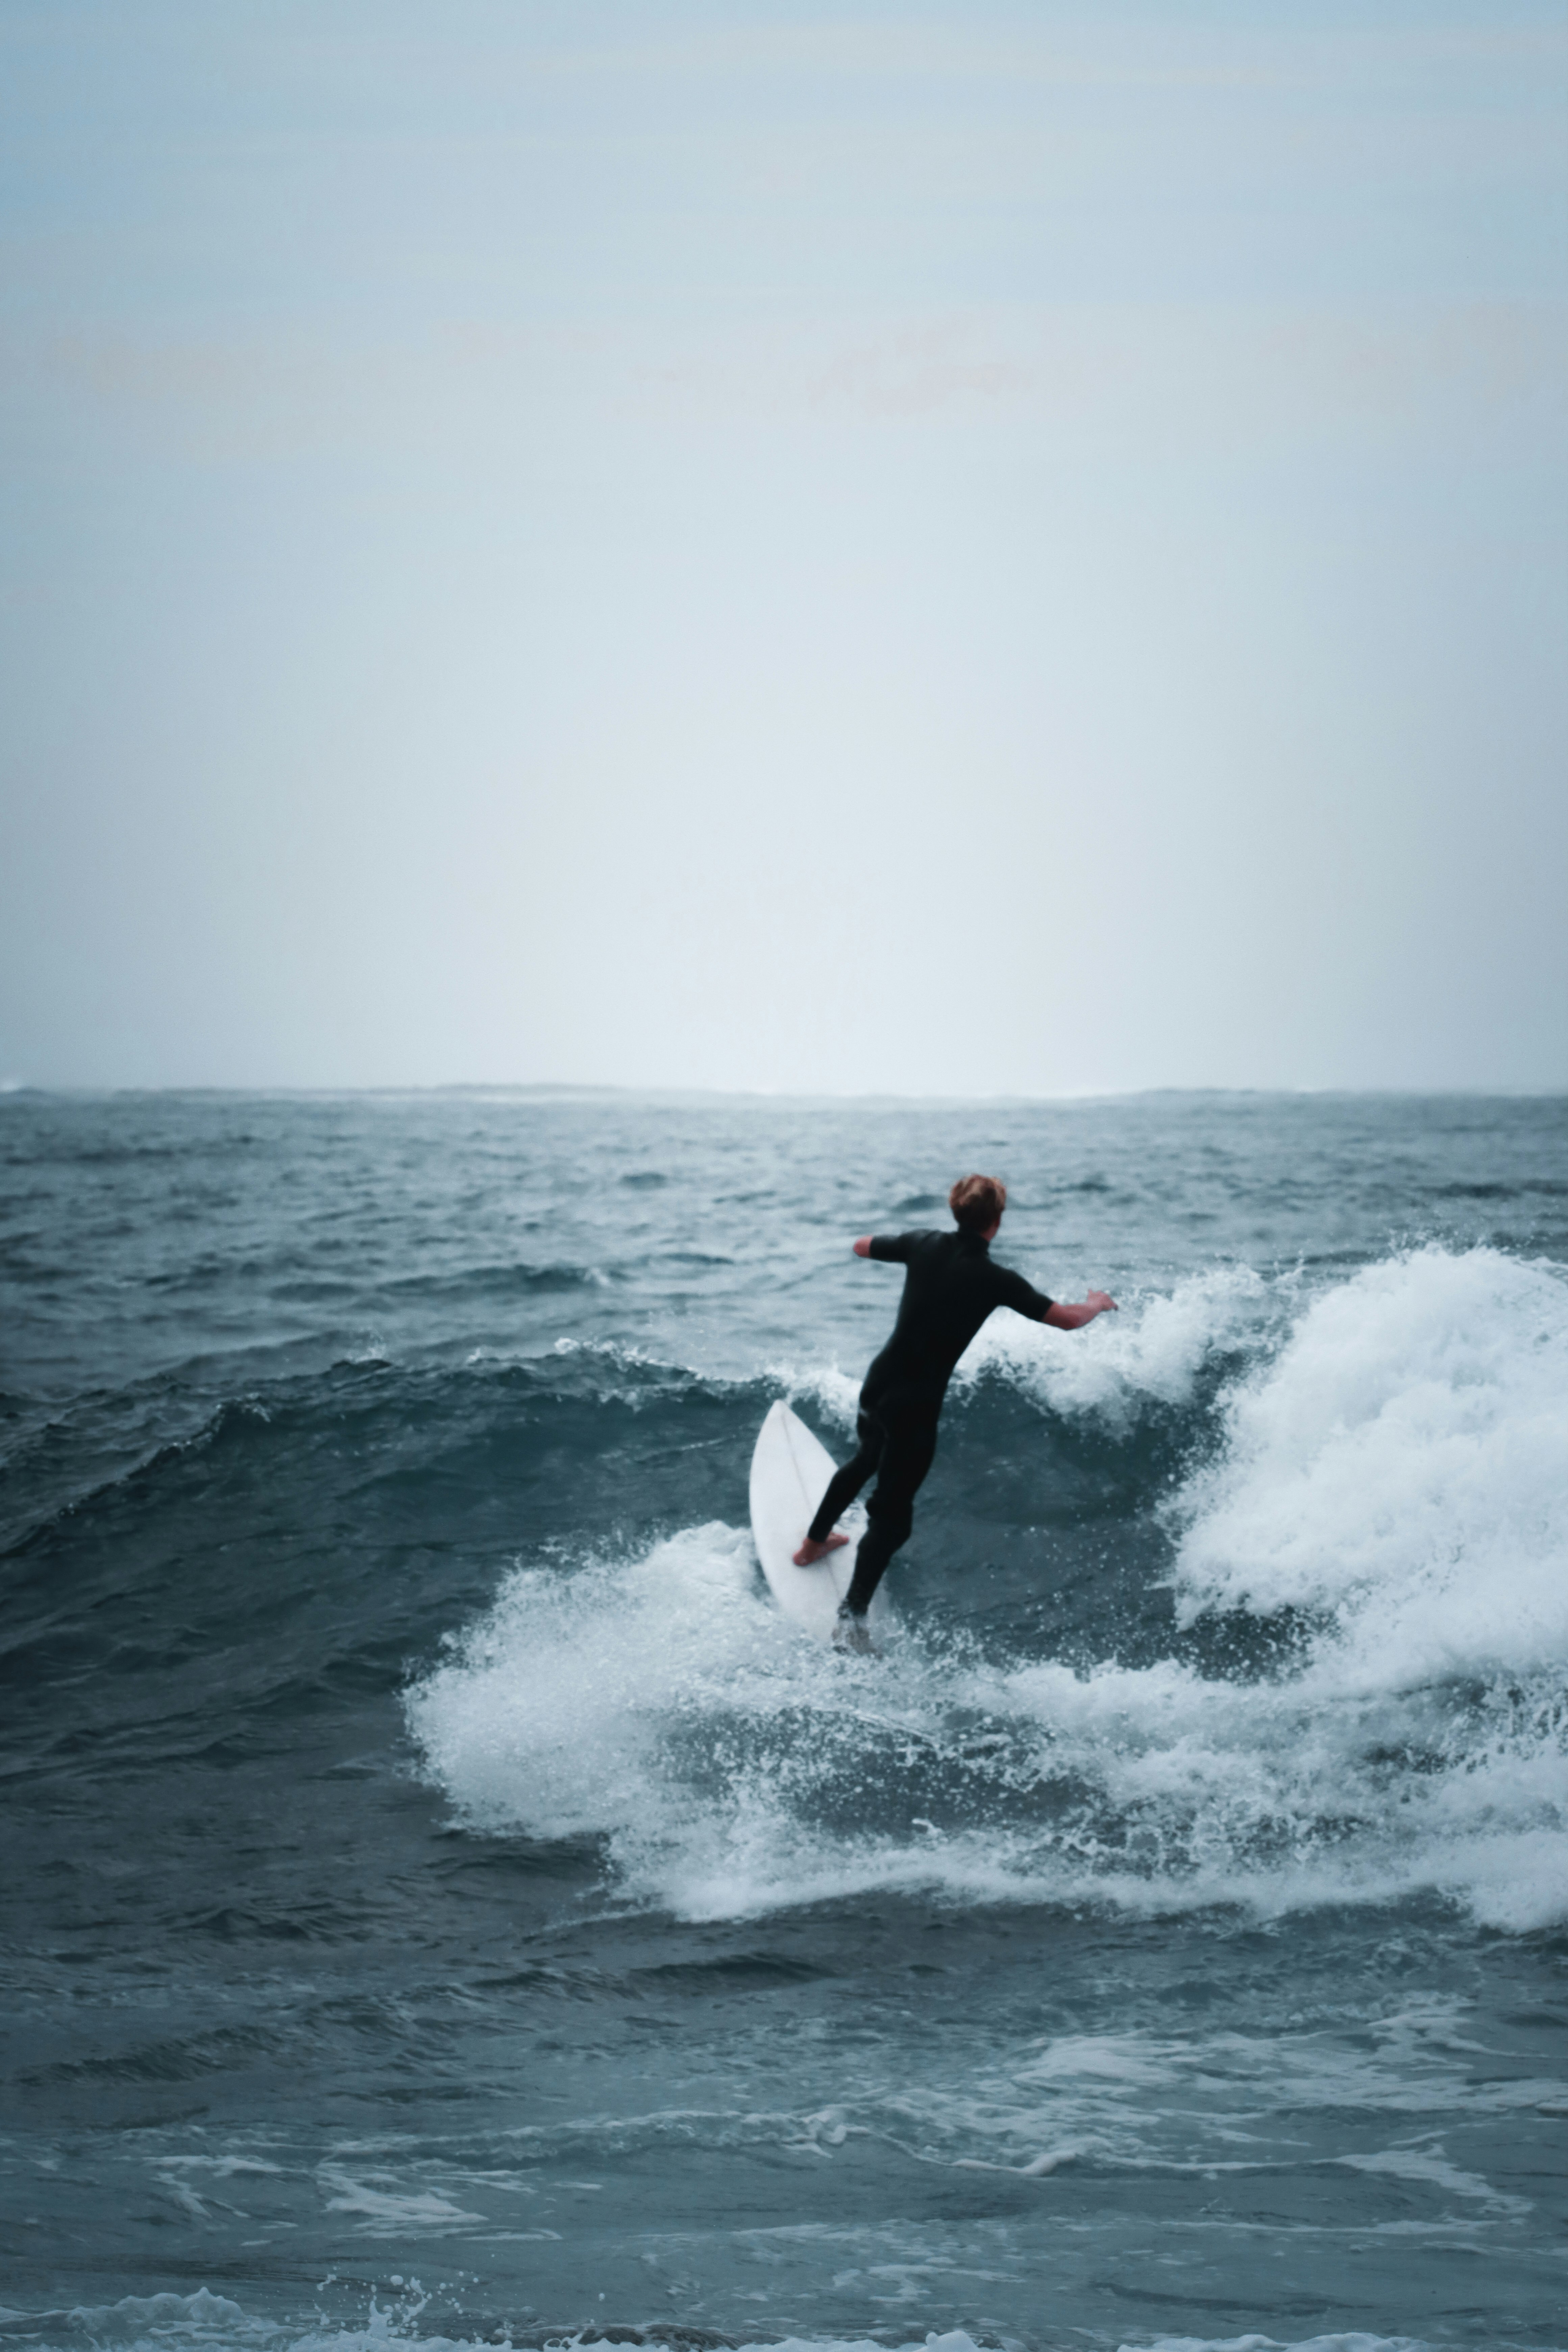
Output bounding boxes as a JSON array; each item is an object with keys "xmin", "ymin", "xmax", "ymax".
[{"xmin": 1180, "ymin": 1249, "xmax": 1568, "ymax": 1689}]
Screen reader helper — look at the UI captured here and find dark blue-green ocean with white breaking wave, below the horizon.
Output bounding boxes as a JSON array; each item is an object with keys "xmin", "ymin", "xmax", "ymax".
[{"xmin": 0, "ymin": 1094, "xmax": 1568, "ymax": 2352}]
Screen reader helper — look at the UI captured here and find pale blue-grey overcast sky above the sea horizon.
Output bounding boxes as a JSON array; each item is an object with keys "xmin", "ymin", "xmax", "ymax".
[{"xmin": 0, "ymin": 0, "xmax": 1568, "ymax": 1094}]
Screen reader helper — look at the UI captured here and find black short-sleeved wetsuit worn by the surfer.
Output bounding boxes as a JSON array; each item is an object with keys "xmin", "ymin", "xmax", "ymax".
[{"xmin": 811, "ymin": 1225, "xmax": 1051, "ymax": 1616}]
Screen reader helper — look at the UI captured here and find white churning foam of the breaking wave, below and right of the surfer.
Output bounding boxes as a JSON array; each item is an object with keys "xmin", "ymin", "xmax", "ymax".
[{"xmin": 409, "ymin": 1249, "xmax": 1568, "ymax": 1929}]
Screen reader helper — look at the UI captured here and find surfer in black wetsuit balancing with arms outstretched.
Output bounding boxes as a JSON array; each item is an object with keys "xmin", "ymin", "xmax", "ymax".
[{"xmin": 794, "ymin": 1176, "xmax": 1117, "ymax": 1651}]
